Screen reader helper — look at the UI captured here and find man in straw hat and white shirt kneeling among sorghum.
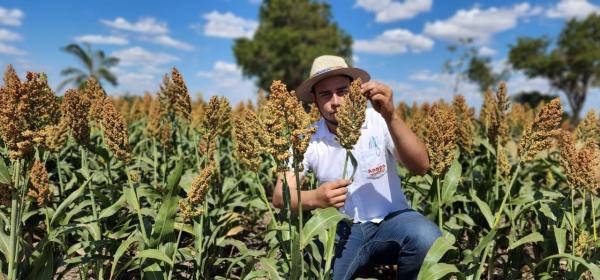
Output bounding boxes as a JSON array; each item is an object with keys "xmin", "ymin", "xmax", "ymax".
[{"xmin": 273, "ymin": 55, "xmax": 441, "ymax": 280}]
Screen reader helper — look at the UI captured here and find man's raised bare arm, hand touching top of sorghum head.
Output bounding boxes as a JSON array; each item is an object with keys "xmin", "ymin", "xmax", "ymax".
[{"xmin": 362, "ymin": 81, "xmax": 429, "ymax": 175}]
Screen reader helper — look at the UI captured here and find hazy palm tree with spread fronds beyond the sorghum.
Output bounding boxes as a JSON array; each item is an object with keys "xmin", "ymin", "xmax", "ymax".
[{"xmin": 57, "ymin": 43, "xmax": 119, "ymax": 91}]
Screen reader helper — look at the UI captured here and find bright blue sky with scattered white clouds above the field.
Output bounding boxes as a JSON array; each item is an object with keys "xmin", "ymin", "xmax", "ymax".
[{"xmin": 0, "ymin": 0, "xmax": 600, "ymax": 115}]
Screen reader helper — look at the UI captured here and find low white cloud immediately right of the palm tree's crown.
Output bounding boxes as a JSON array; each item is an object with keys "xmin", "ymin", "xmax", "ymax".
[{"xmin": 111, "ymin": 47, "xmax": 179, "ymax": 73}]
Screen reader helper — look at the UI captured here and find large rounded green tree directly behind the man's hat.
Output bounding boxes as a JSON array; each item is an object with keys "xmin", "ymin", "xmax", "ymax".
[{"xmin": 233, "ymin": 0, "xmax": 352, "ymax": 92}]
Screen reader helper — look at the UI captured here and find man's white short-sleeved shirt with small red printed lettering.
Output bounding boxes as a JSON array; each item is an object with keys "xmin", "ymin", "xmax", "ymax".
[{"xmin": 302, "ymin": 108, "xmax": 409, "ymax": 223}]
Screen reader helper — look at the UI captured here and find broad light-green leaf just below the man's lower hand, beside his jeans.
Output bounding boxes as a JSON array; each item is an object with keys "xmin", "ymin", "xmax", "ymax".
[{"xmin": 300, "ymin": 207, "xmax": 344, "ymax": 250}]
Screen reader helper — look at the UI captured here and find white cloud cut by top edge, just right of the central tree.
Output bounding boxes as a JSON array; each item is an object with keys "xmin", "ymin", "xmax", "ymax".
[{"xmin": 355, "ymin": 0, "xmax": 433, "ymax": 22}]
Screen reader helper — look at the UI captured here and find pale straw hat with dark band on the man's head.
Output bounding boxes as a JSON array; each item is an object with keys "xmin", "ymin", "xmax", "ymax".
[{"xmin": 296, "ymin": 55, "xmax": 371, "ymax": 102}]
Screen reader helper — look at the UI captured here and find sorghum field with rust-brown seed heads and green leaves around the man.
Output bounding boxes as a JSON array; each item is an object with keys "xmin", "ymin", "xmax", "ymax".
[{"xmin": 0, "ymin": 63, "xmax": 600, "ymax": 279}]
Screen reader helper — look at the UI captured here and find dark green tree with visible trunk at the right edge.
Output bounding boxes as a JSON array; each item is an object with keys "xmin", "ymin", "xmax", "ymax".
[{"xmin": 509, "ymin": 14, "xmax": 600, "ymax": 123}]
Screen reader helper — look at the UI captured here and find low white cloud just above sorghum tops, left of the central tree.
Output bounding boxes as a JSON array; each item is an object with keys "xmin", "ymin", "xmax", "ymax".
[{"xmin": 197, "ymin": 60, "xmax": 257, "ymax": 104}]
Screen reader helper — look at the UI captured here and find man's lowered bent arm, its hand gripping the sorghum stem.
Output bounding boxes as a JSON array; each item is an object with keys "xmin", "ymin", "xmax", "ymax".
[{"xmin": 273, "ymin": 171, "xmax": 351, "ymax": 212}]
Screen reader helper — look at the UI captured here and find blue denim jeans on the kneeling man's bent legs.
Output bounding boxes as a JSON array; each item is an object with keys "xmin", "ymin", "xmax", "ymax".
[{"xmin": 333, "ymin": 209, "xmax": 441, "ymax": 280}]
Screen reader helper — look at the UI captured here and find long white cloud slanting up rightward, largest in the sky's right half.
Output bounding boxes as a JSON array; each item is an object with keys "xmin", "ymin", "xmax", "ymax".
[{"xmin": 424, "ymin": 2, "xmax": 540, "ymax": 44}]
